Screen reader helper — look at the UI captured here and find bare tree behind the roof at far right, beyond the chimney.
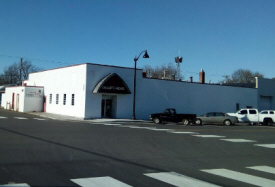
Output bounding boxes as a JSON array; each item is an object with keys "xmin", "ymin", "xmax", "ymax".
[{"xmin": 222, "ymin": 69, "xmax": 264, "ymax": 83}]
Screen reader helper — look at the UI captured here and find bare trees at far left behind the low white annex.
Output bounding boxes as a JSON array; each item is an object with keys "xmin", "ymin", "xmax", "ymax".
[{"xmin": 0, "ymin": 60, "xmax": 42, "ymax": 85}]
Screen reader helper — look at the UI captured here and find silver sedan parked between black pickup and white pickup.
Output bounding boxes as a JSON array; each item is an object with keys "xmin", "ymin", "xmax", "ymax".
[{"xmin": 197, "ymin": 112, "xmax": 239, "ymax": 126}]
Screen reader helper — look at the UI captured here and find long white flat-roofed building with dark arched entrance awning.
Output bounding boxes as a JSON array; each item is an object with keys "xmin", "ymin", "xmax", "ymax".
[{"xmin": 2, "ymin": 63, "xmax": 275, "ymax": 119}]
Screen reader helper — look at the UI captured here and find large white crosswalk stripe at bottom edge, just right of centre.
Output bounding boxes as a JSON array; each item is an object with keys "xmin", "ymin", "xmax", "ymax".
[{"xmin": 144, "ymin": 172, "xmax": 222, "ymax": 187}]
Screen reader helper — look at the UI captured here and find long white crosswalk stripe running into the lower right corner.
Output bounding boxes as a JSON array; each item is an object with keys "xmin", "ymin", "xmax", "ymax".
[{"xmin": 201, "ymin": 169, "xmax": 275, "ymax": 187}]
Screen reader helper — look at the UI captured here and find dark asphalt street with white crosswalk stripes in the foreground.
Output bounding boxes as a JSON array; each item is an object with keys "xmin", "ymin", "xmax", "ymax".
[{"xmin": 0, "ymin": 109, "xmax": 275, "ymax": 187}]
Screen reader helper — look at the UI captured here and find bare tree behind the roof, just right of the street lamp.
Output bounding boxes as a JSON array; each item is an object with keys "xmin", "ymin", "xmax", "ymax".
[{"xmin": 143, "ymin": 63, "xmax": 183, "ymax": 80}]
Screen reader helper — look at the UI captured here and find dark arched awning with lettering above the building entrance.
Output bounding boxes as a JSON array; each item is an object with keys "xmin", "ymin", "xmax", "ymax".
[{"xmin": 93, "ymin": 73, "xmax": 131, "ymax": 94}]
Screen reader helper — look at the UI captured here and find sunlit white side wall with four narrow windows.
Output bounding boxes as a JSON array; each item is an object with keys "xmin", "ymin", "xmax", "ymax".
[{"xmin": 27, "ymin": 64, "xmax": 86, "ymax": 118}]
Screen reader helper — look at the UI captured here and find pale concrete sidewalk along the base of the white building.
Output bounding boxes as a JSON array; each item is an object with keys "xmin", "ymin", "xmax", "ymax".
[{"xmin": 27, "ymin": 112, "xmax": 149, "ymax": 123}]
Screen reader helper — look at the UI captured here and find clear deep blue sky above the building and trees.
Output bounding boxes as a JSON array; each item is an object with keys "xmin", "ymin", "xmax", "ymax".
[{"xmin": 0, "ymin": 0, "xmax": 275, "ymax": 82}]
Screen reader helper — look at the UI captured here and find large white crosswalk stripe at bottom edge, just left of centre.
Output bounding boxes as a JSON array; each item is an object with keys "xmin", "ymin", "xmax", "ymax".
[{"xmin": 71, "ymin": 177, "xmax": 131, "ymax": 187}]
